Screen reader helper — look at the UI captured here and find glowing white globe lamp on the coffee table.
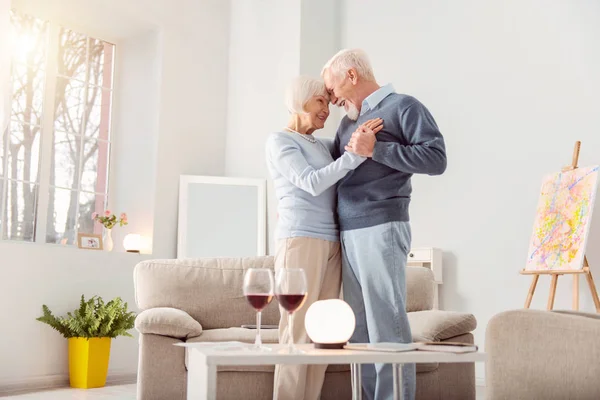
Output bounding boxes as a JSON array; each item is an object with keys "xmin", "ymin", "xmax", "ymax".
[{"xmin": 304, "ymin": 299, "xmax": 356, "ymax": 349}]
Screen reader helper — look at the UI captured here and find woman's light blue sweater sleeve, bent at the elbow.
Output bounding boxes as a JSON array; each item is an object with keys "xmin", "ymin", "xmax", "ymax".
[{"xmin": 267, "ymin": 137, "xmax": 366, "ymax": 196}]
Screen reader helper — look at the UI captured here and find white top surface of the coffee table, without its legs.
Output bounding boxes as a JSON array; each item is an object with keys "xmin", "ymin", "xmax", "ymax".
[{"xmin": 175, "ymin": 342, "xmax": 486, "ymax": 365}]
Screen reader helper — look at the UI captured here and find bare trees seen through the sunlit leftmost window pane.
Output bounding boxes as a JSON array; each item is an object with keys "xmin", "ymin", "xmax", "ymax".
[{"xmin": 0, "ymin": 13, "xmax": 48, "ymax": 241}]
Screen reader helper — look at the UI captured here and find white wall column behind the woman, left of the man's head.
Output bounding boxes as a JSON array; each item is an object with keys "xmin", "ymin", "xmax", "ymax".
[{"xmin": 226, "ymin": 0, "xmax": 340, "ymax": 252}]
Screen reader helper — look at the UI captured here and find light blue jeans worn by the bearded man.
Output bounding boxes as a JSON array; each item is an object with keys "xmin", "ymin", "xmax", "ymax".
[{"xmin": 341, "ymin": 221, "xmax": 416, "ymax": 400}]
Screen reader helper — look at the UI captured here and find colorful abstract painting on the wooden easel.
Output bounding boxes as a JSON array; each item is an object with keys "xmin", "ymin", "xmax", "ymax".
[{"xmin": 525, "ymin": 166, "xmax": 598, "ymax": 271}]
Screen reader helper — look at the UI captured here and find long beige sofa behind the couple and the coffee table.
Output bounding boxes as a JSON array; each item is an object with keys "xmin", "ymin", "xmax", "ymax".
[{"xmin": 134, "ymin": 257, "xmax": 476, "ymax": 400}]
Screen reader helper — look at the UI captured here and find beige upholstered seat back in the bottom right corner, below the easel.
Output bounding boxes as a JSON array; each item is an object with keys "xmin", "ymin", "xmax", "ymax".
[{"xmin": 485, "ymin": 309, "xmax": 600, "ymax": 400}]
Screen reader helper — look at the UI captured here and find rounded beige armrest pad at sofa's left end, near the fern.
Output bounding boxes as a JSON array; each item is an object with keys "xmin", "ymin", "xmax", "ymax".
[{"xmin": 135, "ymin": 307, "xmax": 202, "ymax": 339}]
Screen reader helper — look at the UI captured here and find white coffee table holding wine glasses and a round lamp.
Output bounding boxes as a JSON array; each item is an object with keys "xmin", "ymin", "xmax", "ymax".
[{"xmin": 176, "ymin": 343, "xmax": 486, "ymax": 400}]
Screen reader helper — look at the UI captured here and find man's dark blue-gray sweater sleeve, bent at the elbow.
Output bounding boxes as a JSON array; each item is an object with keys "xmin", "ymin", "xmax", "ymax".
[{"xmin": 373, "ymin": 101, "xmax": 446, "ymax": 175}]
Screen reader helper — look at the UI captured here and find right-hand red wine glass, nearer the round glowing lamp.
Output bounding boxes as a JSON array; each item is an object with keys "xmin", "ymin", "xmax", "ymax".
[{"xmin": 275, "ymin": 268, "xmax": 307, "ymax": 353}]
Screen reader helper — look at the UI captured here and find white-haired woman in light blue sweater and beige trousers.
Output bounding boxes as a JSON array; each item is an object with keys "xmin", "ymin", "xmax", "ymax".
[{"xmin": 266, "ymin": 76, "xmax": 382, "ymax": 400}]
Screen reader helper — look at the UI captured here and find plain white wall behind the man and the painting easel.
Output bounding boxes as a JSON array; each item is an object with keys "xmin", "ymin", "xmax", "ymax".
[{"xmin": 342, "ymin": 0, "xmax": 600, "ymax": 377}]
